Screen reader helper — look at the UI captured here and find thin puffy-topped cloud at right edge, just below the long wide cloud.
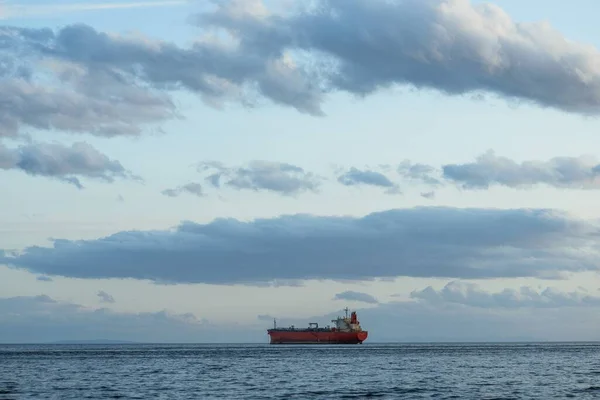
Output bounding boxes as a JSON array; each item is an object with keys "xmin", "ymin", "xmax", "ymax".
[{"xmin": 410, "ymin": 281, "xmax": 600, "ymax": 309}]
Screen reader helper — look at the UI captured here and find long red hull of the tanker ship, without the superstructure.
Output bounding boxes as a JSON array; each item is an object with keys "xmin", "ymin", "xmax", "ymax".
[{"xmin": 267, "ymin": 329, "xmax": 368, "ymax": 344}]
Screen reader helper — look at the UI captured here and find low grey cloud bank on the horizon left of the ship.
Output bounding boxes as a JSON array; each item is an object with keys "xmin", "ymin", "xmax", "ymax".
[{"xmin": 0, "ymin": 295, "xmax": 265, "ymax": 343}]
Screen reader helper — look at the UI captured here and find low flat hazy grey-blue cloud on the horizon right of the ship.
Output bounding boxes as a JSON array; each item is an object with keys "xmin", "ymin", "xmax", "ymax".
[{"xmin": 352, "ymin": 301, "xmax": 600, "ymax": 343}]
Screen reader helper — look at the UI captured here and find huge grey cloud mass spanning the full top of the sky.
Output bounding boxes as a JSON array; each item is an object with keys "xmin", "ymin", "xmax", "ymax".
[{"xmin": 0, "ymin": 0, "xmax": 600, "ymax": 141}]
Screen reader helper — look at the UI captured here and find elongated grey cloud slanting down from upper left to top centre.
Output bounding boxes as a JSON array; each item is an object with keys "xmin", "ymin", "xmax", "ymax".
[{"xmin": 0, "ymin": 20, "xmax": 322, "ymax": 115}]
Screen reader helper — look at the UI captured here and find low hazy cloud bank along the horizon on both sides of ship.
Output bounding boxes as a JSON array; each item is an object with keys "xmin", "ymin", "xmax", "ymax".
[{"xmin": 0, "ymin": 289, "xmax": 600, "ymax": 343}]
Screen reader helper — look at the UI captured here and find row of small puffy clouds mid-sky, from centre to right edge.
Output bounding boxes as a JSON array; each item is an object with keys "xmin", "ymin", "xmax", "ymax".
[{"xmin": 163, "ymin": 150, "xmax": 600, "ymax": 200}]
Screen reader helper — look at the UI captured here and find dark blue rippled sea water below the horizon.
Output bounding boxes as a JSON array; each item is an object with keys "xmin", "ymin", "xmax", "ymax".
[{"xmin": 0, "ymin": 343, "xmax": 600, "ymax": 399}]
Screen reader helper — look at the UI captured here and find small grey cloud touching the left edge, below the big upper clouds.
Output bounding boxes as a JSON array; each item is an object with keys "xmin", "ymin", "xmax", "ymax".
[{"xmin": 0, "ymin": 142, "xmax": 134, "ymax": 189}]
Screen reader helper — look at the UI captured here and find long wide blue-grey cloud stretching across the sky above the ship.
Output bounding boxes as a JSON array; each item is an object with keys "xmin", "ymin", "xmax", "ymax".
[{"xmin": 0, "ymin": 207, "xmax": 599, "ymax": 284}]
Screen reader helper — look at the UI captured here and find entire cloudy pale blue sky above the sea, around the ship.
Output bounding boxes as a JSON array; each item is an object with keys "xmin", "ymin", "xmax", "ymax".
[{"xmin": 0, "ymin": 0, "xmax": 600, "ymax": 343}]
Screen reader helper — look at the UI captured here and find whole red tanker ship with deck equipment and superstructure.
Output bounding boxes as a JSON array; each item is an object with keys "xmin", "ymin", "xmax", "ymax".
[{"xmin": 267, "ymin": 308, "xmax": 369, "ymax": 344}]
